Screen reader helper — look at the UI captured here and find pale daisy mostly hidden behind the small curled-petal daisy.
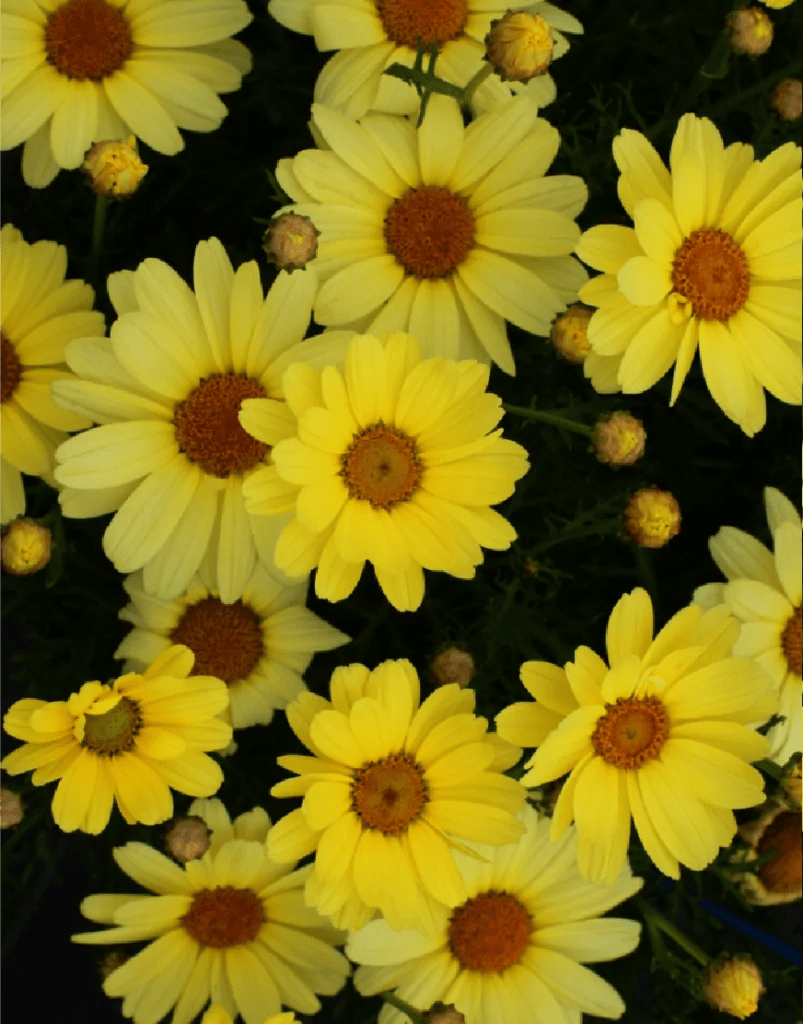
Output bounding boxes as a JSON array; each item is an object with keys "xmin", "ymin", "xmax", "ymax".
[{"xmin": 115, "ymin": 564, "xmax": 349, "ymax": 729}]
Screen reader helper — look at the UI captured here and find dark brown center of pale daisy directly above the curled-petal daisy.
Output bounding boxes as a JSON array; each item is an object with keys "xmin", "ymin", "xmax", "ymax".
[{"xmin": 169, "ymin": 597, "xmax": 265, "ymax": 686}]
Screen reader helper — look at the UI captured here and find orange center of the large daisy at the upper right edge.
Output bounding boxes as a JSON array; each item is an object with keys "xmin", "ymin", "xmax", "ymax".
[{"xmin": 672, "ymin": 228, "xmax": 750, "ymax": 321}]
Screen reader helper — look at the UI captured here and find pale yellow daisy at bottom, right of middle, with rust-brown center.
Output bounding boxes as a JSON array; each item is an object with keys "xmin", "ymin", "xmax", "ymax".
[{"xmin": 346, "ymin": 805, "xmax": 643, "ymax": 1024}]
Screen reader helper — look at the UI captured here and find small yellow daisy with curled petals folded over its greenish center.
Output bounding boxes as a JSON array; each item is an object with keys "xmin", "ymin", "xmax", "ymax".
[{"xmin": 0, "ymin": 645, "xmax": 231, "ymax": 836}]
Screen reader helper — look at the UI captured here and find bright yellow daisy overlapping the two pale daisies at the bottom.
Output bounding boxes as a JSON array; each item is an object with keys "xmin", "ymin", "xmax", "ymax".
[{"xmin": 267, "ymin": 659, "xmax": 524, "ymax": 930}]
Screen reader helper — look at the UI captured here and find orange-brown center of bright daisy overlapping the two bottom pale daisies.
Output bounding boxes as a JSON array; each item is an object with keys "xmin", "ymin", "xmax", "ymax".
[{"xmin": 351, "ymin": 754, "xmax": 429, "ymax": 836}]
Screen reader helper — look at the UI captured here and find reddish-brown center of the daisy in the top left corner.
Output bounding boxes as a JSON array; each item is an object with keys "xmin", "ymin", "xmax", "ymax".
[{"xmin": 45, "ymin": 0, "xmax": 134, "ymax": 82}]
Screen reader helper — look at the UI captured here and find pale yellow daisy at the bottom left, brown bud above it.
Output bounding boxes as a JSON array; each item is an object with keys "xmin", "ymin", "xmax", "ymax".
[{"xmin": 73, "ymin": 800, "xmax": 350, "ymax": 1024}]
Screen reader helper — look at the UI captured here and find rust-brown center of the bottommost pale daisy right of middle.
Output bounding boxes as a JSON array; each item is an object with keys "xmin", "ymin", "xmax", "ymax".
[{"xmin": 449, "ymin": 891, "xmax": 533, "ymax": 972}]
